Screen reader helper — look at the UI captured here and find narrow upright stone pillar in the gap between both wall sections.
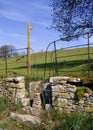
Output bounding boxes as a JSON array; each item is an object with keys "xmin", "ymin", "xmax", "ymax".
[{"xmin": 29, "ymin": 81, "xmax": 43, "ymax": 116}]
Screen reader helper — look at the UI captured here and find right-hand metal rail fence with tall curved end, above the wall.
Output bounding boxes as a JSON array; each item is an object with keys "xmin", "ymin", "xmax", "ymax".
[{"xmin": 44, "ymin": 40, "xmax": 93, "ymax": 79}]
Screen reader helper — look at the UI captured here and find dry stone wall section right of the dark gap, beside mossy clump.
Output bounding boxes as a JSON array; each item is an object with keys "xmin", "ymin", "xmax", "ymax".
[{"xmin": 50, "ymin": 76, "xmax": 93, "ymax": 113}]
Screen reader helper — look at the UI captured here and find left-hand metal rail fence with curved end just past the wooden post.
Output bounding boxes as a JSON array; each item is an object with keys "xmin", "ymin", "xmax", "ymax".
[{"xmin": 0, "ymin": 48, "xmax": 44, "ymax": 79}]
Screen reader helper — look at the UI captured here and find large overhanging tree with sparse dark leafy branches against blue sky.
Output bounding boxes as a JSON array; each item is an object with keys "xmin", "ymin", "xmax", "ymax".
[{"xmin": 52, "ymin": 0, "xmax": 93, "ymax": 40}]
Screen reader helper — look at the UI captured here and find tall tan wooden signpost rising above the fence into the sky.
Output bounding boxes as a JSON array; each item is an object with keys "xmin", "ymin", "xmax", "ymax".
[{"xmin": 27, "ymin": 23, "xmax": 32, "ymax": 75}]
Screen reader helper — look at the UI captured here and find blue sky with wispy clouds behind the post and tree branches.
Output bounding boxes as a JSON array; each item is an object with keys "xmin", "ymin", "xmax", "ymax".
[{"xmin": 0, "ymin": 0, "xmax": 93, "ymax": 52}]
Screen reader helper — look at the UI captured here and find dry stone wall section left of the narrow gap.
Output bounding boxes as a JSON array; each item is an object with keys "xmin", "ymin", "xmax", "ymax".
[{"xmin": 1, "ymin": 77, "xmax": 29, "ymax": 107}]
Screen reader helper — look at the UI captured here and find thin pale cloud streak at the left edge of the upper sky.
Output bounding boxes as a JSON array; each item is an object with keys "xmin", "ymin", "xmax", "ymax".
[{"xmin": 0, "ymin": 10, "xmax": 28, "ymax": 22}]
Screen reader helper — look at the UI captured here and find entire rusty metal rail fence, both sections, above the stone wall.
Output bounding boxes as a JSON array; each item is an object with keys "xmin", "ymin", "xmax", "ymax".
[{"xmin": 0, "ymin": 40, "xmax": 93, "ymax": 80}]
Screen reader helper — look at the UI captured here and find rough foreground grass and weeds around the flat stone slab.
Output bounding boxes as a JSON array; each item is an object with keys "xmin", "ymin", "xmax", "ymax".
[{"xmin": 0, "ymin": 98, "xmax": 93, "ymax": 130}]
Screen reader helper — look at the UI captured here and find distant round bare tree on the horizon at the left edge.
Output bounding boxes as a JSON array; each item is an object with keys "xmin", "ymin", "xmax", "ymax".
[{"xmin": 0, "ymin": 45, "xmax": 17, "ymax": 58}]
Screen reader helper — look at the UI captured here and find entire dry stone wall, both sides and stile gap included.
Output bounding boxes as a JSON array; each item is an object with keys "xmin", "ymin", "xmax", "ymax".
[{"xmin": 0, "ymin": 76, "xmax": 93, "ymax": 116}]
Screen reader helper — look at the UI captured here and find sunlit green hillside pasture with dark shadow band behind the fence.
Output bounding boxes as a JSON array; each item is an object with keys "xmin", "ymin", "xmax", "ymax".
[{"xmin": 0, "ymin": 47, "xmax": 93, "ymax": 79}]
